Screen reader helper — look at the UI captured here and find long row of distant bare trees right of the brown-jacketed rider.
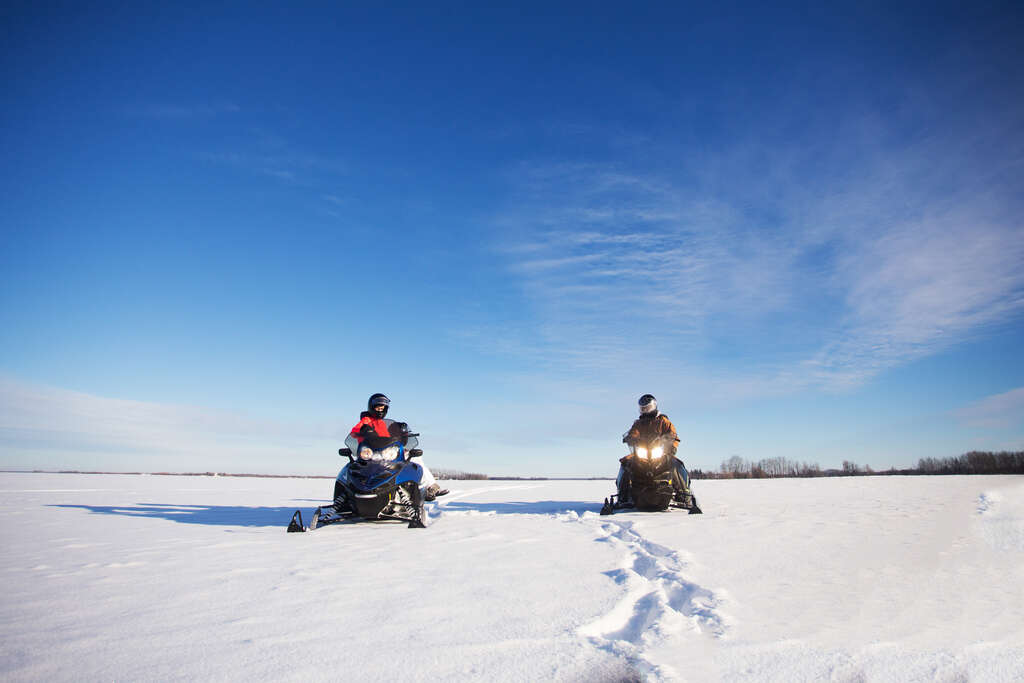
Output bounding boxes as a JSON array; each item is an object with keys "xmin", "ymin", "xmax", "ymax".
[{"xmin": 690, "ymin": 451, "xmax": 1024, "ymax": 479}]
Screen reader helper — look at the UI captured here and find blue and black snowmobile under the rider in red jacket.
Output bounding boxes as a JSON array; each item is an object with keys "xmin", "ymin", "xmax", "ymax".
[{"xmin": 288, "ymin": 420, "xmax": 427, "ymax": 531}]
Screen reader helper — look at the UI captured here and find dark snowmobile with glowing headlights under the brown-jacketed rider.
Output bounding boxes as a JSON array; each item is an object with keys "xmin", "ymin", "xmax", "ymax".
[{"xmin": 601, "ymin": 435, "xmax": 701, "ymax": 515}]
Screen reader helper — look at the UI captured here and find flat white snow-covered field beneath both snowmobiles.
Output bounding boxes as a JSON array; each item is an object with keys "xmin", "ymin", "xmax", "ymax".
[{"xmin": 0, "ymin": 473, "xmax": 1024, "ymax": 682}]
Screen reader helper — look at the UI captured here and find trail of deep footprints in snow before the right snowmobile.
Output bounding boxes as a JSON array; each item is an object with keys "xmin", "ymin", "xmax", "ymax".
[{"xmin": 579, "ymin": 515, "xmax": 729, "ymax": 680}]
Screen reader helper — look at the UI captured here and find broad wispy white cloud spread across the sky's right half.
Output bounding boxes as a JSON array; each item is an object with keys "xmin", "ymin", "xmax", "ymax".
[{"xmin": 483, "ymin": 105, "xmax": 1024, "ymax": 401}]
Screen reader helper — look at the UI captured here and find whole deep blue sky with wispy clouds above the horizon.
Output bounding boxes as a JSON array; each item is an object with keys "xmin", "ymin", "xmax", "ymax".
[{"xmin": 0, "ymin": 3, "xmax": 1024, "ymax": 476}]
